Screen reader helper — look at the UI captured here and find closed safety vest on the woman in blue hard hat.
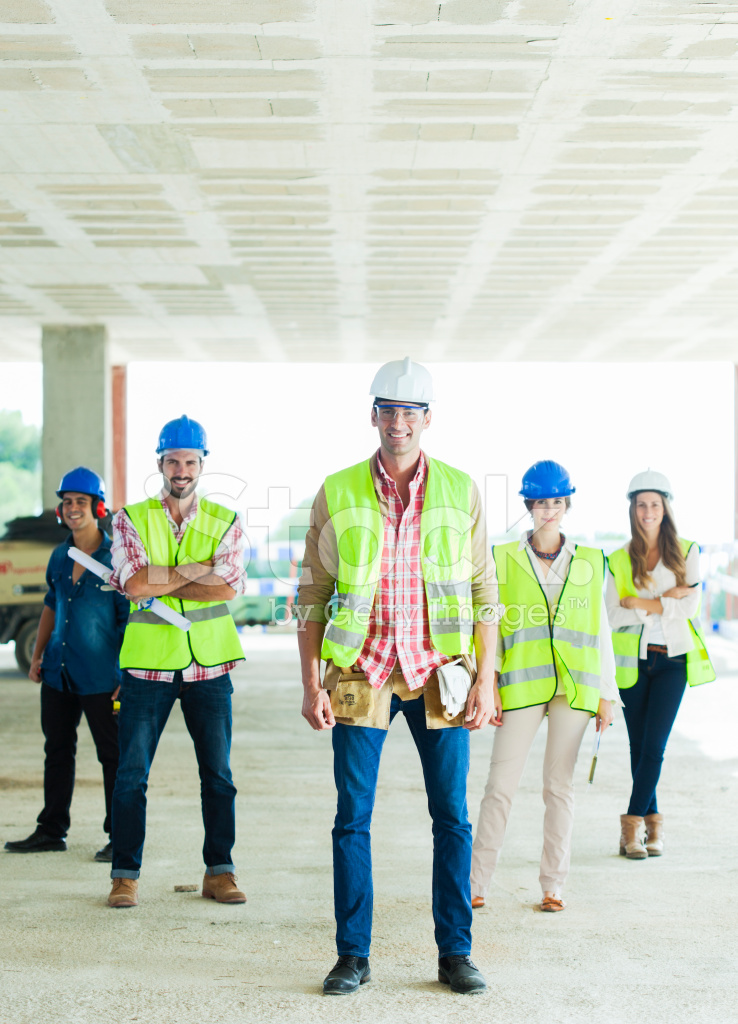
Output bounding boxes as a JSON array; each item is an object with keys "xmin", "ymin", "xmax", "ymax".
[{"xmin": 492, "ymin": 541, "xmax": 605, "ymax": 714}]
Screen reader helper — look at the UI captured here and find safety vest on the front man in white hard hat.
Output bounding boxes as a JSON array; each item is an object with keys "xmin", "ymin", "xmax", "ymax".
[{"xmin": 321, "ymin": 459, "xmax": 474, "ymax": 668}]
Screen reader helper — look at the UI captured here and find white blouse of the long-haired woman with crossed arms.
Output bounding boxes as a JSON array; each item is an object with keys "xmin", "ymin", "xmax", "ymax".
[{"xmin": 605, "ymin": 542, "xmax": 702, "ymax": 658}]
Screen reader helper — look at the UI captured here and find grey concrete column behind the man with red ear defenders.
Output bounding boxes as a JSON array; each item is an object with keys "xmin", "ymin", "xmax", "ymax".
[{"xmin": 41, "ymin": 325, "xmax": 112, "ymax": 508}]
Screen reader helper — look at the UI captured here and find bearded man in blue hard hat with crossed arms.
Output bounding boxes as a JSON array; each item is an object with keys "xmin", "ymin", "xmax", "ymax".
[{"xmin": 107, "ymin": 416, "xmax": 246, "ymax": 908}]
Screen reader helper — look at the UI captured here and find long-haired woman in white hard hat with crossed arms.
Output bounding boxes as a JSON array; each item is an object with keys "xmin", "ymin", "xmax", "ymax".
[{"xmin": 607, "ymin": 469, "xmax": 714, "ymax": 860}]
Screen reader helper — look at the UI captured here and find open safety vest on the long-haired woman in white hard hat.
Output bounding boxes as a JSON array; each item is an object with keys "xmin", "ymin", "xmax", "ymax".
[{"xmin": 607, "ymin": 538, "xmax": 715, "ymax": 690}]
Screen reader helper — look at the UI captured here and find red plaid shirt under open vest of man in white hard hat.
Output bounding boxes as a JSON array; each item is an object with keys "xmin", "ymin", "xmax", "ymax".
[{"xmin": 358, "ymin": 452, "xmax": 453, "ymax": 690}]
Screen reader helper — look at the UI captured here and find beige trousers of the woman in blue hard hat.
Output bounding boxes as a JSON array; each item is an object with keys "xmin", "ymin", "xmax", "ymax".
[{"xmin": 472, "ymin": 695, "xmax": 592, "ymax": 896}]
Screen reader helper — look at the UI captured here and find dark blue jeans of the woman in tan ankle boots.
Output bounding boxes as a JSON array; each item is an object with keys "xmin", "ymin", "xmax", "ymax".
[{"xmin": 620, "ymin": 650, "xmax": 687, "ymax": 818}]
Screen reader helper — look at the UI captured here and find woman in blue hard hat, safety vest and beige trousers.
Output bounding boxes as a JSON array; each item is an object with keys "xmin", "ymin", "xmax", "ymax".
[{"xmin": 471, "ymin": 461, "xmax": 617, "ymax": 911}]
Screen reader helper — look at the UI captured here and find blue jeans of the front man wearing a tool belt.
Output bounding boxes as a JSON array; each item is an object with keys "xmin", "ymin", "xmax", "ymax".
[{"xmin": 333, "ymin": 693, "xmax": 472, "ymax": 956}]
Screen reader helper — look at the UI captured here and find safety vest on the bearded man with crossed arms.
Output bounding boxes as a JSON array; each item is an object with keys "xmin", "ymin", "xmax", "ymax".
[{"xmin": 121, "ymin": 498, "xmax": 244, "ymax": 672}]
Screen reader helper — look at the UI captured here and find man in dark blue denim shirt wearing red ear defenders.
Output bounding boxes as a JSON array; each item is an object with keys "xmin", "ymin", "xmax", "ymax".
[{"xmin": 5, "ymin": 466, "xmax": 128, "ymax": 861}]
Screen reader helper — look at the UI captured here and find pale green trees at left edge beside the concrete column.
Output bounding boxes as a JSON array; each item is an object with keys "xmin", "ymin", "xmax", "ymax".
[{"xmin": 0, "ymin": 410, "xmax": 41, "ymax": 534}]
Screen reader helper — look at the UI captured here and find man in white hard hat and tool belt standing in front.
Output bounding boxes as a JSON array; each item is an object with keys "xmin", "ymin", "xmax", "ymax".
[{"xmin": 298, "ymin": 358, "xmax": 498, "ymax": 995}]
